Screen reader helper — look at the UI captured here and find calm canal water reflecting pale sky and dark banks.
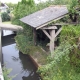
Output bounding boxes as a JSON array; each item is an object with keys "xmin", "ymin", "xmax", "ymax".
[{"xmin": 2, "ymin": 30, "xmax": 40, "ymax": 80}]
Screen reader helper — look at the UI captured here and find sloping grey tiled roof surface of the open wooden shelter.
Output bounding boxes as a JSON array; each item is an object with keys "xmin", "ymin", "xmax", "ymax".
[{"xmin": 20, "ymin": 6, "xmax": 68, "ymax": 28}]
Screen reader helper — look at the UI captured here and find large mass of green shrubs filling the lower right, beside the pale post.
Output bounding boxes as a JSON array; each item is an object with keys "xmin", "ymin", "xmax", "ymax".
[{"xmin": 38, "ymin": 25, "xmax": 80, "ymax": 80}]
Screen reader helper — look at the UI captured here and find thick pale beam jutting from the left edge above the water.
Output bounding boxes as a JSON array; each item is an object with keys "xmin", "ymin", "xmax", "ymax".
[{"xmin": 0, "ymin": 23, "xmax": 23, "ymax": 31}]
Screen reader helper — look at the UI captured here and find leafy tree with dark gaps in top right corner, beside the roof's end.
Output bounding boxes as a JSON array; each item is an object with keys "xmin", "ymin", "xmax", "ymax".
[{"xmin": 68, "ymin": 0, "xmax": 80, "ymax": 22}]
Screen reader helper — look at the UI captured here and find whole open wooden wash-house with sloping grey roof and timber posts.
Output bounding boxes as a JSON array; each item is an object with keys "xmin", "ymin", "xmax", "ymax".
[{"xmin": 20, "ymin": 5, "xmax": 68, "ymax": 53}]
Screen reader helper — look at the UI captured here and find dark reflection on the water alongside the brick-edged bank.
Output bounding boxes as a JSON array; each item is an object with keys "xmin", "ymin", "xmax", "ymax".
[{"xmin": 19, "ymin": 52, "xmax": 39, "ymax": 80}]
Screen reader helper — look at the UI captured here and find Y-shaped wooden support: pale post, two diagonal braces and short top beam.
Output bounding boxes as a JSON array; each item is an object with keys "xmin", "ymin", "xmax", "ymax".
[{"xmin": 41, "ymin": 26, "xmax": 62, "ymax": 56}]
